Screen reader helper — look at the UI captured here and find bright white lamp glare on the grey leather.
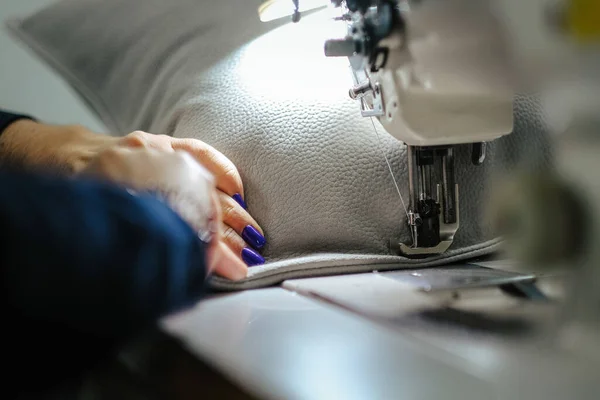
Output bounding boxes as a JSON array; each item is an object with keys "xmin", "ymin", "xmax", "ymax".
[{"xmin": 237, "ymin": 10, "xmax": 352, "ymax": 101}]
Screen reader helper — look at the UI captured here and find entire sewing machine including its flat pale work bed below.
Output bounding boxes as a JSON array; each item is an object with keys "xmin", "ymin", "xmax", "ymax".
[{"xmin": 85, "ymin": 0, "xmax": 600, "ymax": 400}]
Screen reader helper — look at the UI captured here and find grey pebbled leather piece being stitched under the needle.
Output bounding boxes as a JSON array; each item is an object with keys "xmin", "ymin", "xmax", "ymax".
[{"xmin": 9, "ymin": 0, "xmax": 549, "ymax": 289}]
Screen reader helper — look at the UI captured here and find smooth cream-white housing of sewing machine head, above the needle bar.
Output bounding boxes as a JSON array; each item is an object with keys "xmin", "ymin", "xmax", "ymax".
[{"xmin": 370, "ymin": 0, "xmax": 513, "ymax": 146}]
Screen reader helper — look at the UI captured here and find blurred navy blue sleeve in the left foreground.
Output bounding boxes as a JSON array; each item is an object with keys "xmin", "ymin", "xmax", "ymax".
[{"xmin": 0, "ymin": 173, "xmax": 206, "ymax": 390}]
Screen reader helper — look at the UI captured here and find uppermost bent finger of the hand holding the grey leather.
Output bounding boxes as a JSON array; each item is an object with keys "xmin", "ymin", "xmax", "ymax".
[{"xmin": 171, "ymin": 139, "xmax": 244, "ymax": 198}]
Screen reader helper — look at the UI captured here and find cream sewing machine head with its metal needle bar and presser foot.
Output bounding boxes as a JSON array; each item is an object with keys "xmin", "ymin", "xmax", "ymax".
[{"xmin": 294, "ymin": 0, "xmax": 512, "ymax": 257}]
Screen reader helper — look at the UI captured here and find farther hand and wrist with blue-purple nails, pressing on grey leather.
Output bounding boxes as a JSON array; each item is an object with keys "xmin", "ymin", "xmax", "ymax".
[{"xmin": 0, "ymin": 120, "xmax": 265, "ymax": 266}]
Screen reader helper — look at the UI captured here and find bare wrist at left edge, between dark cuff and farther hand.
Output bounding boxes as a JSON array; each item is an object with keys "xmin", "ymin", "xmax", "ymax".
[{"xmin": 0, "ymin": 119, "xmax": 117, "ymax": 175}]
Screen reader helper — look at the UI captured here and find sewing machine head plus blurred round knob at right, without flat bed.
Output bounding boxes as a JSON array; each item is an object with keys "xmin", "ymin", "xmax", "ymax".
[{"xmin": 293, "ymin": 0, "xmax": 600, "ymax": 366}]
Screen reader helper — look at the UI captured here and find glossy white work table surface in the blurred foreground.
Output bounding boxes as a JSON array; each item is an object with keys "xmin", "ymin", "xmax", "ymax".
[{"xmin": 162, "ymin": 266, "xmax": 600, "ymax": 400}]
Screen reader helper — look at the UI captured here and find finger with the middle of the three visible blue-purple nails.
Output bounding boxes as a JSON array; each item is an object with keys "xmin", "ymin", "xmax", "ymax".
[{"xmin": 218, "ymin": 192, "xmax": 266, "ymax": 249}]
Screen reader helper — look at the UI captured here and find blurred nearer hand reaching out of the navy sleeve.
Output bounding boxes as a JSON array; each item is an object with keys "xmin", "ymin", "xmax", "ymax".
[{"xmin": 82, "ymin": 146, "xmax": 247, "ymax": 280}]
